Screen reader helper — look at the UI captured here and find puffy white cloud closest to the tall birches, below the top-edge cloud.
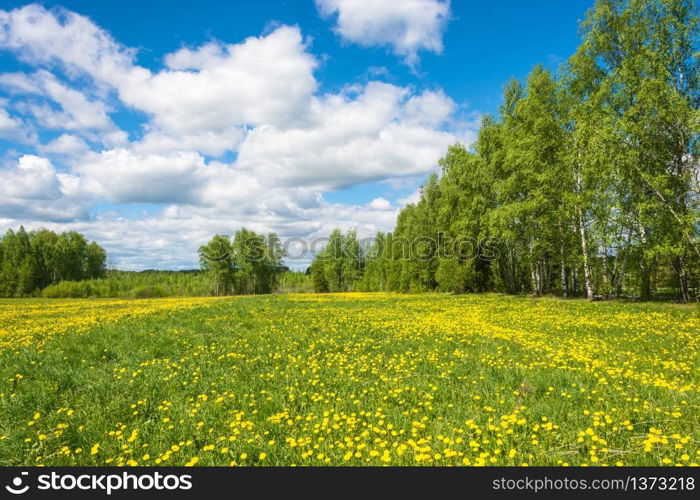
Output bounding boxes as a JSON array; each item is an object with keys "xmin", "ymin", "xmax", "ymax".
[{"xmin": 237, "ymin": 82, "xmax": 456, "ymax": 189}]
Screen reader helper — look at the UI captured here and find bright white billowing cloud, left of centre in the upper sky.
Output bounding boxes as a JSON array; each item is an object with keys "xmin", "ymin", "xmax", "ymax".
[{"xmin": 119, "ymin": 26, "xmax": 316, "ymax": 132}]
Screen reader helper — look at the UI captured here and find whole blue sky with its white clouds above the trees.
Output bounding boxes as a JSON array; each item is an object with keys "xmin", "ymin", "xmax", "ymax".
[{"xmin": 0, "ymin": 0, "xmax": 592, "ymax": 269}]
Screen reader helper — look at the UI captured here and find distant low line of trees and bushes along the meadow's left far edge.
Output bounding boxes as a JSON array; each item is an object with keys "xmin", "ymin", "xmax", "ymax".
[{"xmin": 0, "ymin": 227, "xmax": 313, "ymax": 298}]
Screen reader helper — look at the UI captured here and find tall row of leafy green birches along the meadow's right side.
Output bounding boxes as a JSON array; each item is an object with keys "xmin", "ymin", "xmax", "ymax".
[{"xmin": 312, "ymin": 0, "xmax": 700, "ymax": 301}]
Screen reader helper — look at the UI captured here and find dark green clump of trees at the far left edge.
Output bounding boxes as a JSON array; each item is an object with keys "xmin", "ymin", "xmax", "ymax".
[{"xmin": 0, "ymin": 227, "xmax": 106, "ymax": 297}]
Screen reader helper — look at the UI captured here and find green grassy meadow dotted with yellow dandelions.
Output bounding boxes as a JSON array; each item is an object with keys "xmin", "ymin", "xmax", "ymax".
[{"xmin": 0, "ymin": 294, "xmax": 700, "ymax": 465}]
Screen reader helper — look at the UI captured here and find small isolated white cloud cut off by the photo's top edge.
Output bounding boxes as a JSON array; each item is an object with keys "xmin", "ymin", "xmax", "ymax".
[{"xmin": 316, "ymin": 0, "xmax": 450, "ymax": 66}]
